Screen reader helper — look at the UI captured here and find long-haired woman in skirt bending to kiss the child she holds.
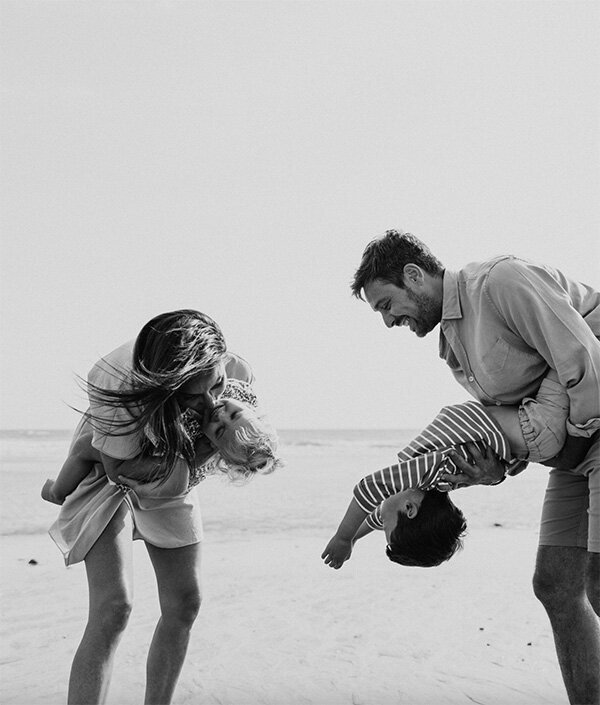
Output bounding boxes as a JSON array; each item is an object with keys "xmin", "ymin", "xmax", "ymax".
[{"xmin": 51, "ymin": 310, "xmax": 264, "ymax": 705}]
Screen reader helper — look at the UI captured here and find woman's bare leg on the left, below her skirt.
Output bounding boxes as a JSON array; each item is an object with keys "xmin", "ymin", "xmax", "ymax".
[{"xmin": 68, "ymin": 504, "xmax": 132, "ymax": 705}]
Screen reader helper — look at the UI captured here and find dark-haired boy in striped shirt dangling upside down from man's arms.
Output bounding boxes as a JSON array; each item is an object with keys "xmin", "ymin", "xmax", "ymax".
[{"xmin": 321, "ymin": 371, "xmax": 580, "ymax": 569}]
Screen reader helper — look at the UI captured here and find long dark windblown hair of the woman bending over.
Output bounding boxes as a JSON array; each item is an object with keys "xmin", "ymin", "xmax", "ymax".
[{"xmin": 86, "ymin": 309, "xmax": 227, "ymax": 481}]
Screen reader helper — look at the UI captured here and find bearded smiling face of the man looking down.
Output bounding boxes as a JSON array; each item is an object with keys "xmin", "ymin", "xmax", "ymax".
[{"xmin": 364, "ymin": 276, "xmax": 442, "ymax": 338}]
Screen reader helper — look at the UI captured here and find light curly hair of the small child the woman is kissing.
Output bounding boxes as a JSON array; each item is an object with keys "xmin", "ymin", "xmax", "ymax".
[{"xmin": 217, "ymin": 415, "xmax": 283, "ymax": 482}]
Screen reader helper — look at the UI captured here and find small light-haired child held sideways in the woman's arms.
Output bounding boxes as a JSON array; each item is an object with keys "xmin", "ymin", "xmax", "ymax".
[{"xmin": 42, "ymin": 379, "xmax": 282, "ymax": 505}]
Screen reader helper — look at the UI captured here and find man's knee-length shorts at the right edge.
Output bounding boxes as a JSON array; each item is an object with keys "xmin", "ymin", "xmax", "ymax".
[{"xmin": 540, "ymin": 432, "xmax": 600, "ymax": 553}]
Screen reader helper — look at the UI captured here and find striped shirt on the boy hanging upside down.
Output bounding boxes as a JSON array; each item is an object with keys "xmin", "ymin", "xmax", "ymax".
[{"xmin": 354, "ymin": 401, "xmax": 511, "ymax": 529}]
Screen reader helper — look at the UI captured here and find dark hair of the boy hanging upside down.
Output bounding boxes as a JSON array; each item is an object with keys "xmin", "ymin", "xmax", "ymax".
[{"xmin": 386, "ymin": 490, "xmax": 467, "ymax": 568}]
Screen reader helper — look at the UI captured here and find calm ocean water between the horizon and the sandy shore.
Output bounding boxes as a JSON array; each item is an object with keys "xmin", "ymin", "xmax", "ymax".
[{"xmin": 0, "ymin": 429, "xmax": 547, "ymax": 540}]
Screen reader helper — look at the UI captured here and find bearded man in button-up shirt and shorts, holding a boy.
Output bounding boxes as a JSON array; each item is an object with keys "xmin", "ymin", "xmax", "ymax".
[{"xmin": 352, "ymin": 230, "xmax": 600, "ymax": 705}]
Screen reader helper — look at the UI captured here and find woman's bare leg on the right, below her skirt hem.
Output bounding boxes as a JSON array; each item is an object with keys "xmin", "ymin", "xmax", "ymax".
[{"xmin": 144, "ymin": 543, "xmax": 201, "ymax": 705}]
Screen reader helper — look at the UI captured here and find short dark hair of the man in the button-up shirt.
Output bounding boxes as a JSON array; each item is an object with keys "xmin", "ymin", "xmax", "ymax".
[{"xmin": 351, "ymin": 230, "xmax": 444, "ymax": 299}]
